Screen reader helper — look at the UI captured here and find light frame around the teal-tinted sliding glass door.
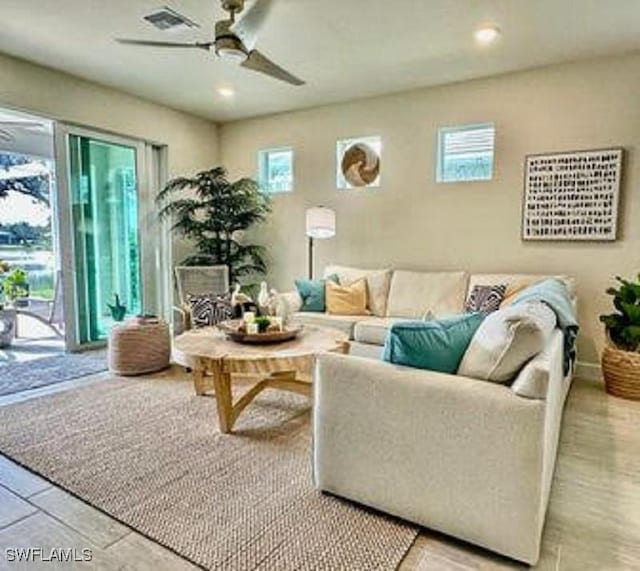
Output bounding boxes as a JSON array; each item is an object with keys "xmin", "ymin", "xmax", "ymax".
[{"xmin": 54, "ymin": 122, "xmax": 150, "ymax": 352}]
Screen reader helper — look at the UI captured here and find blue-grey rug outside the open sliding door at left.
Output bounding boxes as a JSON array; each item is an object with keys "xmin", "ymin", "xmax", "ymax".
[{"xmin": 0, "ymin": 351, "xmax": 107, "ymax": 396}]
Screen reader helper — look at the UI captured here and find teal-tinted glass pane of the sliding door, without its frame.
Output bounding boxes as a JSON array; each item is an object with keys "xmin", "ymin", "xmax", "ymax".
[{"xmin": 68, "ymin": 134, "xmax": 142, "ymax": 345}]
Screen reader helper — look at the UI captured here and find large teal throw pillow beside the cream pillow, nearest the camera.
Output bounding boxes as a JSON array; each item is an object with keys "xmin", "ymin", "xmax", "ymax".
[{"xmin": 383, "ymin": 313, "xmax": 485, "ymax": 374}]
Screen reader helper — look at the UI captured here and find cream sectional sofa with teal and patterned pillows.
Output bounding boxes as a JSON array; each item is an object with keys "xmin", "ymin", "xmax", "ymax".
[{"xmin": 288, "ymin": 267, "xmax": 575, "ymax": 564}]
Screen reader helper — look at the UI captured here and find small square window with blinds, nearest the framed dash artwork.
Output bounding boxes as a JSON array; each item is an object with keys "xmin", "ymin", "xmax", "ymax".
[{"xmin": 436, "ymin": 123, "xmax": 495, "ymax": 182}]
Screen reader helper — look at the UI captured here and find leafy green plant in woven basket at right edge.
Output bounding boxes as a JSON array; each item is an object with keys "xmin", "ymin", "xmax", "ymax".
[{"xmin": 600, "ymin": 275, "xmax": 640, "ymax": 400}]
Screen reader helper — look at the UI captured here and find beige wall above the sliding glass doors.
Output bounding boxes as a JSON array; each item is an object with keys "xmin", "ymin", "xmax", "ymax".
[{"xmin": 0, "ymin": 54, "xmax": 219, "ymax": 261}]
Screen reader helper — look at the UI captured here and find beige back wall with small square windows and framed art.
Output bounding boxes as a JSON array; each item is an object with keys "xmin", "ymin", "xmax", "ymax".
[{"xmin": 220, "ymin": 53, "xmax": 640, "ymax": 363}]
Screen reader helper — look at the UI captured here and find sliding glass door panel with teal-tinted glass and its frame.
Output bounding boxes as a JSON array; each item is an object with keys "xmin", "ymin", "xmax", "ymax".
[{"xmin": 56, "ymin": 128, "xmax": 145, "ymax": 351}]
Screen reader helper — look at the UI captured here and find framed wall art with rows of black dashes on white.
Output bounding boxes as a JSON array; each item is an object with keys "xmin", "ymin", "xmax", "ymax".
[{"xmin": 522, "ymin": 148, "xmax": 623, "ymax": 241}]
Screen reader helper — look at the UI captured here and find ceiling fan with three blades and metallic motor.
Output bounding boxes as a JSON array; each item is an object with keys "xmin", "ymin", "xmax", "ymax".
[{"xmin": 117, "ymin": 0, "xmax": 305, "ymax": 85}]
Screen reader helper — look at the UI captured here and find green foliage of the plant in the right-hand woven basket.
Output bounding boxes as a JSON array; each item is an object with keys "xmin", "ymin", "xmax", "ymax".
[{"xmin": 600, "ymin": 274, "xmax": 640, "ymax": 351}]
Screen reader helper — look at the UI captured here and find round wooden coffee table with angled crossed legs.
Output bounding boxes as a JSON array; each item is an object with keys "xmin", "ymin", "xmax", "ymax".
[{"xmin": 173, "ymin": 326, "xmax": 349, "ymax": 433}]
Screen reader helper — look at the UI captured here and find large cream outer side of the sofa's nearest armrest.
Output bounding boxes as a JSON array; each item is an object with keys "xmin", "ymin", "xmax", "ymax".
[{"xmin": 313, "ymin": 354, "xmax": 545, "ymax": 563}]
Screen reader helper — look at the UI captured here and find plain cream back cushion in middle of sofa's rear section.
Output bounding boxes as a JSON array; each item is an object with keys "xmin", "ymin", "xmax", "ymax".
[{"xmin": 387, "ymin": 270, "xmax": 467, "ymax": 319}]
